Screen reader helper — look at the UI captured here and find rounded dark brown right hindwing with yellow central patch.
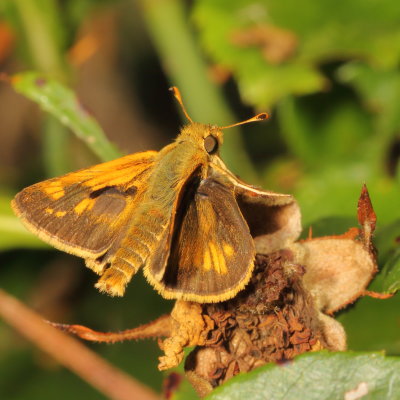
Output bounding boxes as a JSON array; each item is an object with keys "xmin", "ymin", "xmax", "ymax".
[{"xmin": 144, "ymin": 172, "xmax": 255, "ymax": 303}]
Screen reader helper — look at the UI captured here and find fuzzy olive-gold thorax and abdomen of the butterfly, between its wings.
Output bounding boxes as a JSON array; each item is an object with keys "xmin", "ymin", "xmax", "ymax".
[{"xmin": 111, "ymin": 128, "xmax": 216, "ymax": 276}]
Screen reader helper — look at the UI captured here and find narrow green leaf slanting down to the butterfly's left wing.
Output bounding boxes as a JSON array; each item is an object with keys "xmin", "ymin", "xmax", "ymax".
[{"xmin": 12, "ymin": 72, "xmax": 121, "ymax": 161}]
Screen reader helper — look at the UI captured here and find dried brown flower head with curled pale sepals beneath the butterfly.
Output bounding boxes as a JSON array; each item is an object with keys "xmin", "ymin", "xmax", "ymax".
[{"xmin": 50, "ymin": 186, "xmax": 379, "ymax": 396}]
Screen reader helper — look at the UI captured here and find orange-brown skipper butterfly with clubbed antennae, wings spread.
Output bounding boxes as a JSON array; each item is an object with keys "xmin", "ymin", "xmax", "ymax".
[{"xmin": 12, "ymin": 88, "xmax": 294, "ymax": 303}]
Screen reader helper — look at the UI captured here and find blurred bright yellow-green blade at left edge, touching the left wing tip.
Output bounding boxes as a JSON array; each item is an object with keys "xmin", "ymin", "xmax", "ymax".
[{"xmin": 0, "ymin": 195, "xmax": 49, "ymax": 250}]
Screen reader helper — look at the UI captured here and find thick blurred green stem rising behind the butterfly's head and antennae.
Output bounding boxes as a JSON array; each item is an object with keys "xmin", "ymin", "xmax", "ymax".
[{"xmin": 140, "ymin": 0, "xmax": 257, "ymax": 182}]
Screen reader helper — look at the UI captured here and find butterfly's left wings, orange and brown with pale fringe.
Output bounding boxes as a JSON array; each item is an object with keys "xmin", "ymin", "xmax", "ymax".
[{"xmin": 12, "ymin": 151, "xmax": 157, "ymax": 262}]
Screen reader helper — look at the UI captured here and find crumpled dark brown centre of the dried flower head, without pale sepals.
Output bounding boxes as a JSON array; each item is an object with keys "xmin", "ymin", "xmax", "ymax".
[{"xmin": 160, "ymin": 250, "xmax": 336, "ymax": 395}]
